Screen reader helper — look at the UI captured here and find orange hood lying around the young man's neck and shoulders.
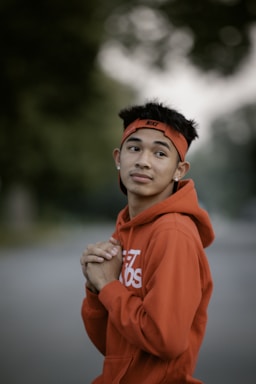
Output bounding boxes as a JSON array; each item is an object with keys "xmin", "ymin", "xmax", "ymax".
[{"xmin": 117, "ymin": 179, "xmax": 214, "ymax": 248}]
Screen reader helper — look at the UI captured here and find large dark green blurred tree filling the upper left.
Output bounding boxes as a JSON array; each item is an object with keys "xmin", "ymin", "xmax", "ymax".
[{"xmin": 0, "ymin": 0, "xmax": 134, "ymax": 222}]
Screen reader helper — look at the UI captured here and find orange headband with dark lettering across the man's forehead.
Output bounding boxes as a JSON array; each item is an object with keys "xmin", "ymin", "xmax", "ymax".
[{"xmin": 121, "ymin": 119, "xmax": 188, "ymax": 161}]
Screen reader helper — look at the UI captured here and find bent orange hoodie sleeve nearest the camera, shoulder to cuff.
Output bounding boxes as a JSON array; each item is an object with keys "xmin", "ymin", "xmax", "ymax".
[{"xmin": 99, "ymin": 225, "xmax": 208, "ymax": 359}]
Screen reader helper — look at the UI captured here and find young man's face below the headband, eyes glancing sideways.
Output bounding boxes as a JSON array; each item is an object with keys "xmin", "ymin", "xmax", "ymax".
[{"xmin": 119, "ymin": 129, "xmax": 179, "ymax": 201}]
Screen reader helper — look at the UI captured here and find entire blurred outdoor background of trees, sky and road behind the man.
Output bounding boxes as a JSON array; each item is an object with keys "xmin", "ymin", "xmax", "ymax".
[{"xmin": 0, "ymin": 0, "xmax": 256, "ymax": 384}]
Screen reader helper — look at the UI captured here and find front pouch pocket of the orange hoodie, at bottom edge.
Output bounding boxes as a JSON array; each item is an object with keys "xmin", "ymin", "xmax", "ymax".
[{"xmin": 103, "ymin": 356, "xmax": 133, "ymax": 384}]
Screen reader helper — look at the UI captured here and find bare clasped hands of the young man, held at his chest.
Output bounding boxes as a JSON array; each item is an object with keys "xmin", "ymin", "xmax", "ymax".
[{"xmin": 80, "ymin": 237, "xmax": 122, "ymax": 293}]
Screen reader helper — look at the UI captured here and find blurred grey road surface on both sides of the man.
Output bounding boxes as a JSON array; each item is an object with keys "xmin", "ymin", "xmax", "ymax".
[{"xmin": 0, "ymin": 221, "xmax": 256, "ymax": 384}]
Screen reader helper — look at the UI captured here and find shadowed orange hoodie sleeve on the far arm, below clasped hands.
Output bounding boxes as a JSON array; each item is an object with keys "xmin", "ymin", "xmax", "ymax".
[{"xmin": 81, "ymin": 288, "xmax": 108, "ymax": 355}]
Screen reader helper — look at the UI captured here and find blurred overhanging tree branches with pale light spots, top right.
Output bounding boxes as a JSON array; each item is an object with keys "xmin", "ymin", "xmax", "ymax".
[{"xmin": 104, "ymin": 0, "xmax": 256, "ymax": 75}]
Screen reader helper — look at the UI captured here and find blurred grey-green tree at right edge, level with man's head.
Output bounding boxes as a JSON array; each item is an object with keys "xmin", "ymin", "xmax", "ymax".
[{"xmin": 191, "ymin": 104, "xmax": 256, "ymax": 218}]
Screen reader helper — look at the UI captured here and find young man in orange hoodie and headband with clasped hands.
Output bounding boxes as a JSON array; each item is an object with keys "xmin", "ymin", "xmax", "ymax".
[{"xmin": 81, "ymin": 102, "xmax": 214, "ymax": 384}]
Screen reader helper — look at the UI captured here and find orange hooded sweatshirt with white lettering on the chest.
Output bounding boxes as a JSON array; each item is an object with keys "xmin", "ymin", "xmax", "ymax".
[{"xmin": 82, "ymin": 180, "xmax": 214, "ymax": 384}]
